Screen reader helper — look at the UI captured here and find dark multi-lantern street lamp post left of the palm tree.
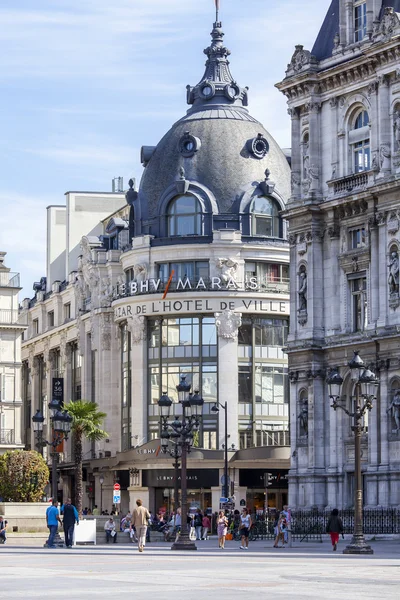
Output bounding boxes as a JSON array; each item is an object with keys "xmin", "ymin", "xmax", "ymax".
[{"xmin": 32, "ymin": 399, "xmax": 72, "ymax": 545}]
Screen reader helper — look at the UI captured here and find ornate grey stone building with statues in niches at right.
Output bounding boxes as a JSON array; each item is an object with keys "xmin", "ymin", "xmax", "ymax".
[{"xmin": 277, "ymin": 0, "xmax": 400, "ymax": 508}]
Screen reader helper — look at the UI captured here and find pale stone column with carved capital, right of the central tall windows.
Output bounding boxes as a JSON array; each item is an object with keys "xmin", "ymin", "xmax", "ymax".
[{"xmin": 215, "ymin": 310, "xmax": 242, "ymax": 448}]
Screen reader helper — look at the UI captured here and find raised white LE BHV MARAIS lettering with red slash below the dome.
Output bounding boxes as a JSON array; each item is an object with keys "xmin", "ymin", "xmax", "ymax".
[{"xmin": 113, "ymin": 277, "xmax": 286, "ymax": 299}]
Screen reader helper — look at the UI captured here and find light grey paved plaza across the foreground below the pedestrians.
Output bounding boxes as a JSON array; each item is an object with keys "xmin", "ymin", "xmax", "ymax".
[{"xmin": 0, "ymin": 540, "xmax": 400, "ymax": 600}]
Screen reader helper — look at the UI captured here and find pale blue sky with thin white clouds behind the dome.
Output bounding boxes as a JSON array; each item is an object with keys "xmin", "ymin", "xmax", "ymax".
[{"xmin": 0, "ymin": 0, "xmax": 330, "ymax": 298}]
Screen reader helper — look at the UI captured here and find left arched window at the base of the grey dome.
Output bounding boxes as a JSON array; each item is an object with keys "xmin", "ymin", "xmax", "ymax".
[{"xmin": 167, "ymin": 195, "xmax": 202, "ymax": 237}]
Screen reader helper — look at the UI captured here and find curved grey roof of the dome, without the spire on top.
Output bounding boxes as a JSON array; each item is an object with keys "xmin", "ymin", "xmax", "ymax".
[{"xmin": 139, "ymin": 106, "xmax": 290, "ymax": 218}]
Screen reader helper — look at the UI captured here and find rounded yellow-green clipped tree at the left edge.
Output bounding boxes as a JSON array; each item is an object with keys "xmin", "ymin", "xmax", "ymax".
[{"xmin": 0, "ymin": 450, "xmax": 49, "ymax": 502}]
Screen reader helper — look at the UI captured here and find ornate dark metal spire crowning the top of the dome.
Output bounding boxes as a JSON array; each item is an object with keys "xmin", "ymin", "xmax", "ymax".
[{"xmin": 187, "ymin": 8, "xmax": 249, "ymax": 110}]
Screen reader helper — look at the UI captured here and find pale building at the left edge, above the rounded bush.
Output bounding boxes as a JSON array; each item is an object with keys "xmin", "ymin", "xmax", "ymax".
[{"xmin": 0, "ymin": 252, "xmax": 26, "ymax": 454}]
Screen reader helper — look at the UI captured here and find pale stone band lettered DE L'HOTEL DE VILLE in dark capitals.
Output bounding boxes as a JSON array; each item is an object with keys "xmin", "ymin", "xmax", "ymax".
[{"xmin": 114, "ymin": 298, "xmax": 289, "ymax": 319}]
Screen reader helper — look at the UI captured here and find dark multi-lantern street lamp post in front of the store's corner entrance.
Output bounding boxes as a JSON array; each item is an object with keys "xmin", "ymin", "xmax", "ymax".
[{"xmin": 158, "ymin": 375, "xmax": 204, "ymax": 550}]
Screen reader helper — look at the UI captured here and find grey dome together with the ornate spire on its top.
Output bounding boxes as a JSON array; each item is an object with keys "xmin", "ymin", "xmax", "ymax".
[{"xmin": 136, "ymin": 22, "xmax": 290, "ymax": 237}]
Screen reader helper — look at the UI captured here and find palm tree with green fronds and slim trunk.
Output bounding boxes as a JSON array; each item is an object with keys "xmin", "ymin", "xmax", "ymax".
[{"xmin": 65, "ymin": 400, "xmax": 108, "ymax": 515}]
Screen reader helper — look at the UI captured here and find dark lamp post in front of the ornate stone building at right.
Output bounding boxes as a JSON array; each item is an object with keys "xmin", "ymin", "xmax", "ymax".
[{"xmin": 327, "ymin": 352, "xmax": 379, "ymax": 554}]
